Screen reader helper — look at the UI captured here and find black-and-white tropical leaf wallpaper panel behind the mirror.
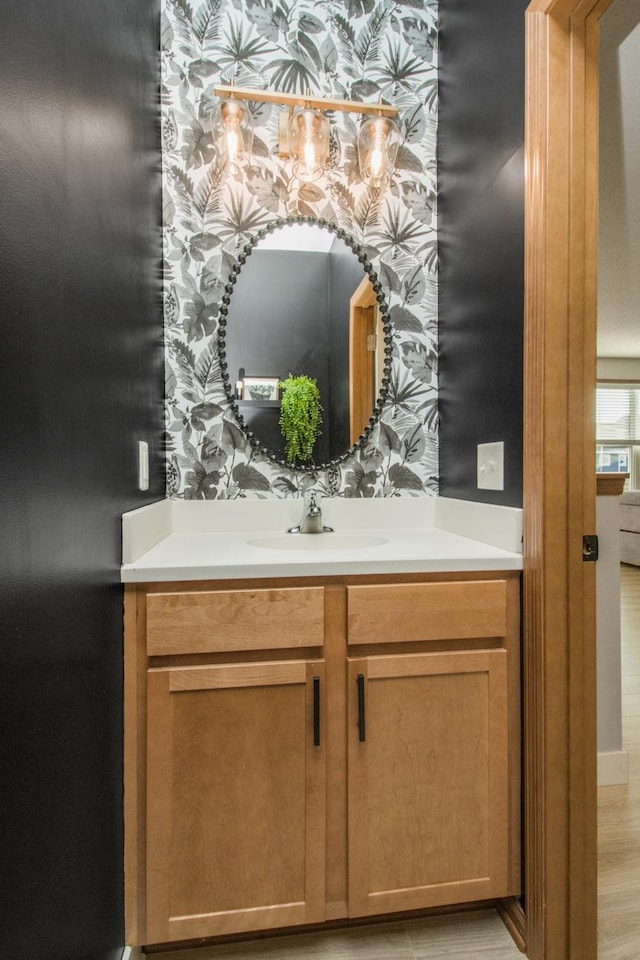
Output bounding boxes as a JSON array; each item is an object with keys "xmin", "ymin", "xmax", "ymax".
[{"xmin": 161, "ymin": 0, "xmax": 438, "ymax": 499}]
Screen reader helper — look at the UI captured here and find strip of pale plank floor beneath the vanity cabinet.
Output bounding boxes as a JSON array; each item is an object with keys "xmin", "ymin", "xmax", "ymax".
[{"xmin": 152, "ymin": 910, "xmax": 522, "ymax": 960}]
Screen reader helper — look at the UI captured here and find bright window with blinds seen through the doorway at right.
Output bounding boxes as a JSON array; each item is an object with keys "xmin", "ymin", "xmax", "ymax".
[{"xmin": 596, "ymin": 381, "xmax": 640, "ymax": 489}]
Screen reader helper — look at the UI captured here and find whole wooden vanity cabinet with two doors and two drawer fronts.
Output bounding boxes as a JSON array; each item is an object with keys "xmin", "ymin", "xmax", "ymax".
[{"xmin": 125, "ymin": 571, "xmax": 520, "ymax": 944}]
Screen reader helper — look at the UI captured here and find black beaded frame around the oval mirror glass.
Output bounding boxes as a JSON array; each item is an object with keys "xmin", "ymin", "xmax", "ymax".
[{"xmin": 218, "ymin": 217, "xmax": 393, "ymax": 473}]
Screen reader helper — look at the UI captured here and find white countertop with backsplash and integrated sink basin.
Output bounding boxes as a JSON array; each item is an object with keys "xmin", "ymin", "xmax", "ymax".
[{"xmin": 122, "ymin": 497, "xmax": 522, "ymax": 583}]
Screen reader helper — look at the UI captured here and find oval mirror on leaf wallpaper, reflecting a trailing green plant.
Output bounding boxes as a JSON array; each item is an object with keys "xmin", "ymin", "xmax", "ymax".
[{"xmin": 219, "ymin": 218, "xmax": 391, "ymax": 469}]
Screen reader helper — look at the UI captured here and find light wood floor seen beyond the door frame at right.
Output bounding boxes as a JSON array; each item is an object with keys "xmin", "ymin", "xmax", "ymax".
[{"xmin": 598, "ymin": 564, "xmax": 640, "ymax": 960}]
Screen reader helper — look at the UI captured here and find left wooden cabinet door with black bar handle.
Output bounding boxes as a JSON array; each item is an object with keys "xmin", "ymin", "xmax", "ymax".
[{"xmin": 146, "ymin": 660, "xmax": 325, "ymax": 943}]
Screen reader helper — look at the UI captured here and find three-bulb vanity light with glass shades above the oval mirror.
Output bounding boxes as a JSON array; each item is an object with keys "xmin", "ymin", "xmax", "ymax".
[{"xmin": 213, "ymin": 85, "xmax": 400, "ymax": 186}]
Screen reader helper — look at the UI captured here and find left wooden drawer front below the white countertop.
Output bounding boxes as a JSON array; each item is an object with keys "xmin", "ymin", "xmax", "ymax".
[{"xmin": 147, "ymin": 587, "xmax": 324, "ymax": 657}]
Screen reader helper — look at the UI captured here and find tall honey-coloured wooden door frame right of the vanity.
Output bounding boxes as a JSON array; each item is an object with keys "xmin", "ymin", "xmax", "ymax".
[{"xmin": 523, "ymin": 0, "xmax": 612, "ymax": 960}]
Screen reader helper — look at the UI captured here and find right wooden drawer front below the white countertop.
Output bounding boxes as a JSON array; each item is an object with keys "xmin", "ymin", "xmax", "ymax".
[{"xmin": 347, "ymin": 580, "xmax": 507, "ymax": 644}]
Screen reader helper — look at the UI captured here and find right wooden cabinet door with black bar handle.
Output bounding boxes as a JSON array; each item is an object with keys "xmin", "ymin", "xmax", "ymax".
[{"xmin": 348, "ymin": 650, "xmax": 509, "ymax": 916}]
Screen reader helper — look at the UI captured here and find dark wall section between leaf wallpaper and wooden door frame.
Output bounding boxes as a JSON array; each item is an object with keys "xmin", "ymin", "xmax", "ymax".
[{"xmin": 438, "ymin": 0, "xmax": 529, "ymax": 506}]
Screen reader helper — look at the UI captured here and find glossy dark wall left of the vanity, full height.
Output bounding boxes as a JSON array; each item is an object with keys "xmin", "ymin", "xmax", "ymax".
[{"xmin": 0, "ymin": 0, "xmax": 164, "ymax": 960}]
